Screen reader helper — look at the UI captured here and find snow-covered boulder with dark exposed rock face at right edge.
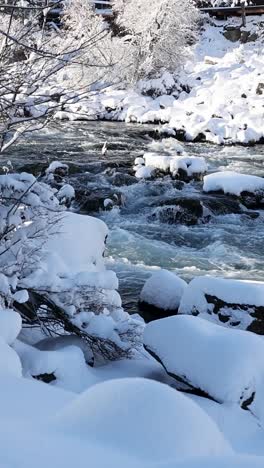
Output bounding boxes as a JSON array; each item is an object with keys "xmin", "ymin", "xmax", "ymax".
[{"xmin": 179, "ymin": 276, "xmax": 264, "ymax": 335}]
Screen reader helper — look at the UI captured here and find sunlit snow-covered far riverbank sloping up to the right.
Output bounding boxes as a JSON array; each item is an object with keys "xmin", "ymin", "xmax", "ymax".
[{"xmin": 51, "ymin": 16, "xmax": 264, "ymax": 145}]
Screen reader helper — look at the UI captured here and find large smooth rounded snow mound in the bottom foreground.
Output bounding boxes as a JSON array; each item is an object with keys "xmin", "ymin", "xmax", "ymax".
[{"xmin": 54, "ymin": 378, "xmax": 232, "ymax": 463}]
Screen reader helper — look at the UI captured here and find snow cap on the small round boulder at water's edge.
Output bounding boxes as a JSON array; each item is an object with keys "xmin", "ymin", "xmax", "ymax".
[{"xmin": 140, "ymin": 270, "xmax": 187, "ymax": 311}]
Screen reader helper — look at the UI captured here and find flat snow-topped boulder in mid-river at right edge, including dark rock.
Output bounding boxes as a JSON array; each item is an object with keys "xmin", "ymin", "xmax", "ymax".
[{"xmin": 203, "ymin": 171, "xmax": 264, "ymax": 209}]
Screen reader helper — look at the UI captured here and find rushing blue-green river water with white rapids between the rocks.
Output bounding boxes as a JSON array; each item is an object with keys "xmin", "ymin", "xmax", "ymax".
[{"xmin": 4, "ymin": 122, "xmax": 264, "ymax": 312}]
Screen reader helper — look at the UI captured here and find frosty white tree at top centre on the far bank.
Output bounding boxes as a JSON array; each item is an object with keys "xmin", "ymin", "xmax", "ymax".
[{"xmin": 113, "ymin": 0, "xmax": 199, "ymax": 80}]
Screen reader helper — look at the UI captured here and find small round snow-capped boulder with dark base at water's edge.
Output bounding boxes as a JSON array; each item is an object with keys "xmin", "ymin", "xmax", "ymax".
[{"xmin": 140, "ymin": 270, "xmax": 187, "ymax": 320}]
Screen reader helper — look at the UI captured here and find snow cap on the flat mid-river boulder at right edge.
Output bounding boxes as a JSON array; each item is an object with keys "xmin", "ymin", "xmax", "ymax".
[{"xmin": 203, "ymin": 171, "xmax": 264, "ymax": 196}]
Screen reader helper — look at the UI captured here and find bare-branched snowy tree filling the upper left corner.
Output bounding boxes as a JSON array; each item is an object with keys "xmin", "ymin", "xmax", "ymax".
[{"xmin": 0, "ymin": 0, "xmax": 114, "ymax": 152}]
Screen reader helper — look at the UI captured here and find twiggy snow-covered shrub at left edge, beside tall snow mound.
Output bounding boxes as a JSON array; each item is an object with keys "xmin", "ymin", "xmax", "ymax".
[{"xmin": 0, "ymin": 173, "xmax": 61, "ymax": 305}]
